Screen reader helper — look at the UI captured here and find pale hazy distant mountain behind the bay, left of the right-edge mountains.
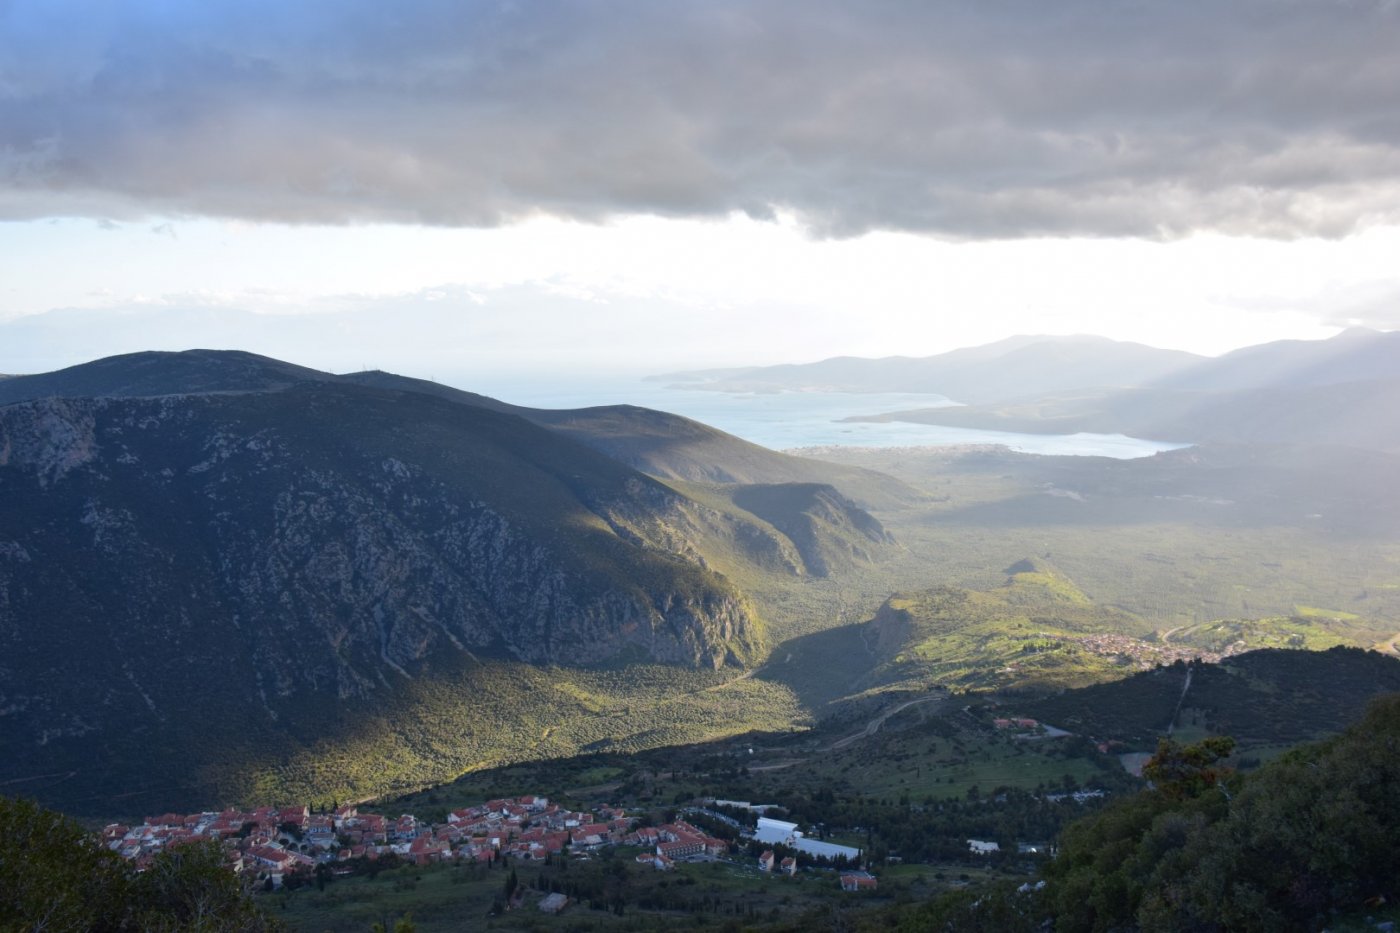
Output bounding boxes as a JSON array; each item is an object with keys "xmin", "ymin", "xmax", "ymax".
[{"xmin": 655, "ymin": 336, "xmax": 1204, "ymax": 403}]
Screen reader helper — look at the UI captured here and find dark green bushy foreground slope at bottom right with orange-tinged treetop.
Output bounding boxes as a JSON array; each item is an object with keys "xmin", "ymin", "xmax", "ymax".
[{"xmin": 869, "ymin": 693, "xmax": 1400, "ymax": 933}]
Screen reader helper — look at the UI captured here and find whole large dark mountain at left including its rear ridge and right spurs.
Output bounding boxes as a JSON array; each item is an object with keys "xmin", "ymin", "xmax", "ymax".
[{"xmin": 0, "ymin": 350, "xmax": 904, "ymax": 793}]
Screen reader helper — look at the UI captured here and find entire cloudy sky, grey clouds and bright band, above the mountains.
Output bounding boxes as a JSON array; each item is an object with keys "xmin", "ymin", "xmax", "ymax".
[{"xmin": 0, "ymin": 0, "xmax": 1400, "ymax": 388}]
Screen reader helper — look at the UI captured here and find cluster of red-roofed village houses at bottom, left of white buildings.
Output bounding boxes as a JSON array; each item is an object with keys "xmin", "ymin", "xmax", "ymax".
[{"xmin": 102, "ymin": 796, "xmax": 875, "ymax": 891}]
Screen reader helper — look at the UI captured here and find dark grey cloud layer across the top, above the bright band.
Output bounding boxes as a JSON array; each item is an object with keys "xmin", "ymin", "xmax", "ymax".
[{"xmin": 0, "ymin": 0, "xmax": 1400, "ymax": 237}]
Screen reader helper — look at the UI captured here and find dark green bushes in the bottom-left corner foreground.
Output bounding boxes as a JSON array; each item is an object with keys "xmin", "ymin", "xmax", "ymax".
[{"xmin": 0, "ymin": 797, "xmax": 283, "ymax": 933}]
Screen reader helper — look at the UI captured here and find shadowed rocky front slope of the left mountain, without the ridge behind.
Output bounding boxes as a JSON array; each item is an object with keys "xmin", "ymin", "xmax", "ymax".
[{"xmin": 0, "ymin": 384, "xmax": 759, "ymax": 747}]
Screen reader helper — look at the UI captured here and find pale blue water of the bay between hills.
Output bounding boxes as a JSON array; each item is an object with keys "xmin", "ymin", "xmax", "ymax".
[{"xmin": 459, "ymin": 369, "xmax": 1183, "ymax": 459}]
